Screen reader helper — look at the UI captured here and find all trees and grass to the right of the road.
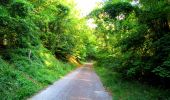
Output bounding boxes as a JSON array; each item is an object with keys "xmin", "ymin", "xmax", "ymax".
[{"xmin": 89, "ymin": 0, "xmax": 170, "ymax": 100}]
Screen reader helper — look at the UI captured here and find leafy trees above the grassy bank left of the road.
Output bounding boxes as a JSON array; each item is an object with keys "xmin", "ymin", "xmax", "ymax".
[{"xmin": 0, "ymin": 0, "xmax": 95, "ymax": 60}]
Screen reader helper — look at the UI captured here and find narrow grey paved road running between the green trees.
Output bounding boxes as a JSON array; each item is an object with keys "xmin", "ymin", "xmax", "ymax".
[{"xmin": 30, "ymin": 63, "xmax": 112, "ymax": 100}]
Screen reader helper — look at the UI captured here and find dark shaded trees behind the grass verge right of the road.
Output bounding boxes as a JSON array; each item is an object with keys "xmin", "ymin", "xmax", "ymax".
[{"xmin": 91, "ymin": 0, "xmax": 170, "ymax": 84}]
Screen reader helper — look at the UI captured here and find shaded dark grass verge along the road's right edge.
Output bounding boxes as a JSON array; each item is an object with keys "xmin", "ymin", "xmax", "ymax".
[{"xmin": 95, "ymin": 67, "xmax": 170, "ymax": 100}]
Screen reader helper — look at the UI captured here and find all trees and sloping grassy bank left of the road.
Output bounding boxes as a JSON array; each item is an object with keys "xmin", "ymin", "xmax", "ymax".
[{"xmin": 0, "ymin": 0, "xmax": 91, "ymax": 100}]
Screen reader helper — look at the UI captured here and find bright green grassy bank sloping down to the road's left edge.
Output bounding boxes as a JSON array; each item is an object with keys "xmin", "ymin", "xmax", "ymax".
[{"xmin": 0, "ymin": 48, "xmax": 75, "ymax": 100}]
